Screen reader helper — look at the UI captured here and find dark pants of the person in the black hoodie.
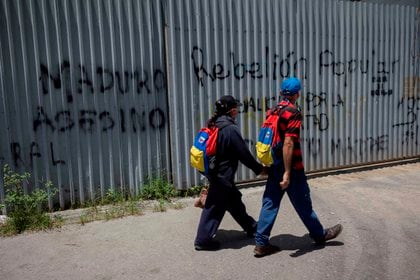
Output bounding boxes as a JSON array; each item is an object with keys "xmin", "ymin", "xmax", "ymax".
[{"xmin": 194, "ymin": 184, "xmax": 257, "ymax": 245}]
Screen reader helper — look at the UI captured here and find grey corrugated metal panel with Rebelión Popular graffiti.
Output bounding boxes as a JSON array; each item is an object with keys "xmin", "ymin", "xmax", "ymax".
[{"xmin": 169, "ymin": 0, "xmax": 420, "ymax": 189}]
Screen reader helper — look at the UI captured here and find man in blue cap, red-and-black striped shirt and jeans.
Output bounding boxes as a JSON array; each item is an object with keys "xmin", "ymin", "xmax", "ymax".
[{"xmin": 254, "ymin": 77, "xmax": 343, "ymax": 257}]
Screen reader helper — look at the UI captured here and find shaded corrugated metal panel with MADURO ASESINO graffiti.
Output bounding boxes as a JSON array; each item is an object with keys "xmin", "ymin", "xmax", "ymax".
[{"xmin": 0, "ymin": 0, "xmax": 170, "ymax": 208}]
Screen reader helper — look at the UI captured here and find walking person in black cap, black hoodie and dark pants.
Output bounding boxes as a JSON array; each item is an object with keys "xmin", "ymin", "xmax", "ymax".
[{"xmin": 194, "ymin": 95, "xmax": 266, "ymax": 250}]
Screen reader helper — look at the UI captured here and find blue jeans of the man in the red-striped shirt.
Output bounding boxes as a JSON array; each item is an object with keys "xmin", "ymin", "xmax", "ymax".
[{"xmin": 255, "ymin": 164, "xmax": 325, "ymax": 246}]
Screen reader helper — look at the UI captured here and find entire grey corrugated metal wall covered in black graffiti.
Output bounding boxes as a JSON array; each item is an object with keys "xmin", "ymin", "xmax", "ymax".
[{"xmin": 0, "ymin": 0, "xmax": 420, "ymax": 208}]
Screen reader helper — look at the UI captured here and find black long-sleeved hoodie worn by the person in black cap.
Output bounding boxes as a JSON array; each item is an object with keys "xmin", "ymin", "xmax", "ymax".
[{"xmin": 209, "ymin": 115, "xmax": 263, "ymax": 187}]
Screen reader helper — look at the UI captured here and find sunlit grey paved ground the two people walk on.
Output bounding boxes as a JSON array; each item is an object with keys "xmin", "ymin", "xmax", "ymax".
[{"xmin": 0, "ymin": 163, "xmax": 420, "ymax": 280}]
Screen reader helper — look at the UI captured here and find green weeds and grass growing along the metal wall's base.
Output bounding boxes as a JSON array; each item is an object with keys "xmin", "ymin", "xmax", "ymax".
[{"xmin": 0, "ymin": 168, "xmax": 202, "ymax": 230}]
